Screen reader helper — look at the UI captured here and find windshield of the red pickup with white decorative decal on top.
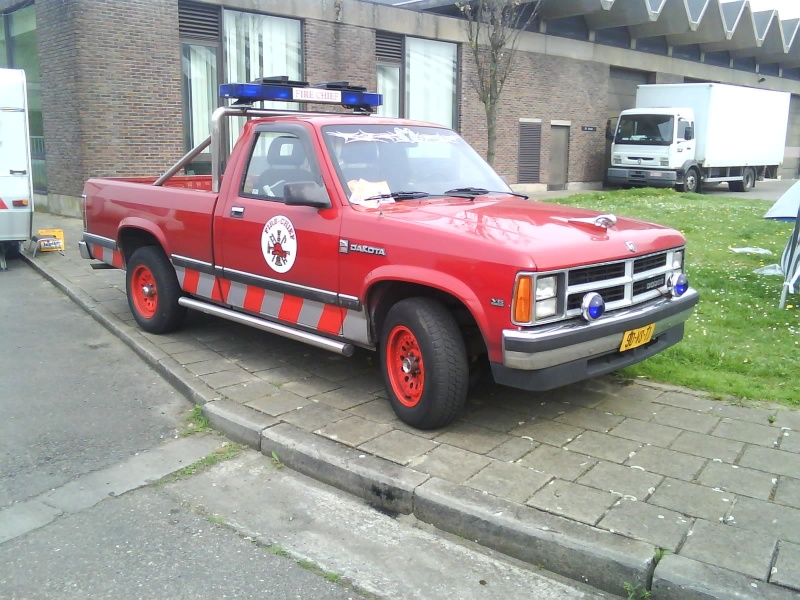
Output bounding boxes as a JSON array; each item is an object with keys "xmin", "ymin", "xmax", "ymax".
[{"xmin": 322, "ymin": 123, "xmax": 511, "ymax": 204}]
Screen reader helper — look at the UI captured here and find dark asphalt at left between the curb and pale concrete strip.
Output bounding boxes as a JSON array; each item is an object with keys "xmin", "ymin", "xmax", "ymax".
[{"xmin": 0, "ymin": 260, "xmax": 189, "ymax": 508}]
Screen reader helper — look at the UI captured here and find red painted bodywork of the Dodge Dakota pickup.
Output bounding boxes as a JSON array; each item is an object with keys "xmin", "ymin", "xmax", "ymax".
[{"xmin": 85, "ymin": 115, "xmax": 685, "ymax": 362}]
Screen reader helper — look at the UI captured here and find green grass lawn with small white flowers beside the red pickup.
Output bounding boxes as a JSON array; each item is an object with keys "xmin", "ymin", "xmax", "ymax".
[{"xmin": 553, "ymin": 188, "xmax": 800, "ymax": 406}]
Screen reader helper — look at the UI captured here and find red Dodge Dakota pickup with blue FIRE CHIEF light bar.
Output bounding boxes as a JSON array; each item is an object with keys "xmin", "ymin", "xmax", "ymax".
[{"xmin": 80, "ymin": 81, "xmax": 698, "ymax": 429}]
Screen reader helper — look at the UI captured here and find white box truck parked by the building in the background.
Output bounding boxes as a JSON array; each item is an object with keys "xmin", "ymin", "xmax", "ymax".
[{"xmin": 608, "ymin": 83, "xmax": 791, "ymax": 192}]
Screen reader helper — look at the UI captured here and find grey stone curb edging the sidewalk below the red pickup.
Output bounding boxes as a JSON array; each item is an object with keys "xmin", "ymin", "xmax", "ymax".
[{"xmin": 18, "ymin": 255, "xmax": 732, "ymax": 599}]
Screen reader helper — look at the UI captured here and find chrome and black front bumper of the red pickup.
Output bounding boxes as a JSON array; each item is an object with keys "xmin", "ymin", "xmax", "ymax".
[{"xmin": 492, "ymin": 288, "xmax": 700, "ymax": 391}]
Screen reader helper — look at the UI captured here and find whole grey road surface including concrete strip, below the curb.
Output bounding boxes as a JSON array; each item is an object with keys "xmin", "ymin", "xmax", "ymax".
[{"xmin": 0, "ymin": 261, "xmax": 609, "ymax": 600}]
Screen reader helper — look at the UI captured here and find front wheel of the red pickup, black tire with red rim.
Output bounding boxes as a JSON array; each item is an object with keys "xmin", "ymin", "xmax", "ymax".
[{"xmin": 380, "ymin": 298, "xmax": 469, "ymax": 429}]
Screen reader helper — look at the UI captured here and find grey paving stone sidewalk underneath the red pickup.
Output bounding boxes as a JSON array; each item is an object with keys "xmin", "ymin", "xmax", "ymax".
[{"xmin": 17, "ymin": 214, "xmax": 800, "ymax": 598}]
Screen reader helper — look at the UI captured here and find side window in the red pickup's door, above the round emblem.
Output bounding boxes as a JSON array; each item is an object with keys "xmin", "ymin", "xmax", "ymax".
[{"xmin": 240, "ymin": 131, "xmax": 321, "ymax": 200}]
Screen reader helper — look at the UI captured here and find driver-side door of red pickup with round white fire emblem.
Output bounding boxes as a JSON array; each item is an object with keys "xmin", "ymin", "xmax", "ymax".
[{"xmin": 214, "ymin": 123, "xmax": 344, "ymax": 335}]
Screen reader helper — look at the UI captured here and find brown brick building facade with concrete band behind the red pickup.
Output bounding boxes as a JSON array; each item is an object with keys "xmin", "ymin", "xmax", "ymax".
[{"xmin": 0, "ymin": 0, "xmax": 800, "ymax": 214}]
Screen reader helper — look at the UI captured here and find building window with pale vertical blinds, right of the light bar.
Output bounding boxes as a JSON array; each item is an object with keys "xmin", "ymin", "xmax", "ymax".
[{"xmin": 375, "ymin": 32, "xmax": 458, "ymax": 129}]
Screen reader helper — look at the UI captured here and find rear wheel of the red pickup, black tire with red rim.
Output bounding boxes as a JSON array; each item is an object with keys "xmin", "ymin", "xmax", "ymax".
[{"xmin": 125, "ymin": 246, "xmax": 186, "ymax": 333}]
